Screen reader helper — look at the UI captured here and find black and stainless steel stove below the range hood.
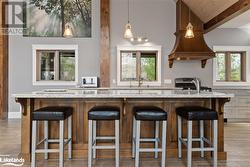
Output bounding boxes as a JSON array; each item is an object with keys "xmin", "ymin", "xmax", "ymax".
[{"xmin": 175, "ymin": 78, "xmax": 212, "ymax": 92}]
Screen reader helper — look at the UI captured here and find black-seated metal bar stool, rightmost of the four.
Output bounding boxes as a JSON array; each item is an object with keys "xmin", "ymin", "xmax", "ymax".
[{"xmin": 176, "ymin": 106, "xmax": 218, "ymax": 167}]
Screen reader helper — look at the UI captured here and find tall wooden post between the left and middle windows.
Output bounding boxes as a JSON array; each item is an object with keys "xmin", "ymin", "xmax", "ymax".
[{"xmin": 100, "ymin": 0, "xmax": 110, "ymax": 87}]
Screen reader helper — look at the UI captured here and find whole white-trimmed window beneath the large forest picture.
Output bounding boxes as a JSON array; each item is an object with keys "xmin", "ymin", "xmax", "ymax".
[{"xmin": 33, "ymin": 45, "xmax": 78, "ymax": 85}]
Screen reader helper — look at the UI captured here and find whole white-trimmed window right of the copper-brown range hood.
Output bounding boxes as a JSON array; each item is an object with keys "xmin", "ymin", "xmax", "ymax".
[{"xmin": 213, "ymin": 46, "xmax": 250, "ymax": 87}]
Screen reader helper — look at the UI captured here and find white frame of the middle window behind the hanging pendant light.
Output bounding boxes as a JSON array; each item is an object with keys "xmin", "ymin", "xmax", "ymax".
[{"xmin": 116, "ymin": 46, "xmax": 162, "ymax": 86}]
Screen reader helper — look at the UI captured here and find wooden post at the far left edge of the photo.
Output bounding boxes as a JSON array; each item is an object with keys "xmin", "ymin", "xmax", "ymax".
[{"xmin": 0, "ymin": 1, "xmax": 9, "ymax": 119}]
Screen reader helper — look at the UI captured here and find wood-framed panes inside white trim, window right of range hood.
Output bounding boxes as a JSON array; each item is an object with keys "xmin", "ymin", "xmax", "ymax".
[{"xmin": 216, "ymin": 51, "xmax": 246, "ymax": 82}]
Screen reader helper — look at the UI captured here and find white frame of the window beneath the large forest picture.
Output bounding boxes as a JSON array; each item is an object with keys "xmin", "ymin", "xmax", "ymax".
[{"xmin": 32, "ymin": 45, "xmax": 78, "ymax": 86}]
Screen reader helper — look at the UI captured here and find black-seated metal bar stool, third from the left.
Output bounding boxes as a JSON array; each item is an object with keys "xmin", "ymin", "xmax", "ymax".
[{"xmin": 132, "ymin": 106, "xmax": 167, "ymax": 167}]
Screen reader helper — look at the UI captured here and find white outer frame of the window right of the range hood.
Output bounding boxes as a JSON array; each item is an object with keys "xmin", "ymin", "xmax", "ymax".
[{"xmin": 213, "ymin": 46, "xmax": 250, "ymax": 86}]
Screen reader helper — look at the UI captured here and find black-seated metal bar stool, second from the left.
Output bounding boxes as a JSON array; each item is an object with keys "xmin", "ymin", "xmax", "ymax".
[{"xmin": 88, "ymin": 106, "xmax": 120, "ymax": 167}]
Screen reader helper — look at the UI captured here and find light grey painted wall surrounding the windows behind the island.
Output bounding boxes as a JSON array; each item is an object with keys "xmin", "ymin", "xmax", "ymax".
[{"xmin": 9, "ymin": 0, "xmax": 250, "ymax": 118}]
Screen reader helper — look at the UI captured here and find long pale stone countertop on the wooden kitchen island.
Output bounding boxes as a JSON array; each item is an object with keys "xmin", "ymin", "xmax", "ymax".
[{"xmin": 13, "ymin": 89, "xmax": 234, "ymax": 98}]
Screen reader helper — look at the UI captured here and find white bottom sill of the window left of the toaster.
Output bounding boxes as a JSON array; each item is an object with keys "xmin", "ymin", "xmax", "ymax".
[{"xmin": 33, "ymin": 81, "xmax": 77, "ymax": 86}]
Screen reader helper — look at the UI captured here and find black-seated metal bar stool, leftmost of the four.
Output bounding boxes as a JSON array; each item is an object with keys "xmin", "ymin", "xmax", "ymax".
[{"xmin": 31, "ymin": 106, "xmax": 73, "ymax": 167}]
